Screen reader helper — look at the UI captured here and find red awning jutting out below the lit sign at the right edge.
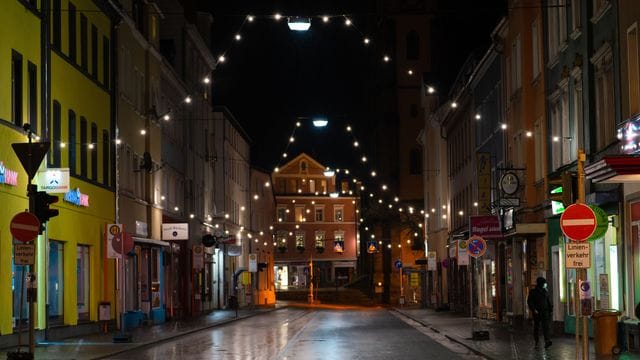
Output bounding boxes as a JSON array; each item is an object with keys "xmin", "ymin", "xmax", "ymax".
[{"xmin": 584, "ymin": 155, "xmax": 640, "ymax": 184}]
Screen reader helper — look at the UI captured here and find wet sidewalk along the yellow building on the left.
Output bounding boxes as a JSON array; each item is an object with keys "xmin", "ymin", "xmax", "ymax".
[{"xmin": 0, "ymin": 304, "xmax": 287, "ymax": 360}]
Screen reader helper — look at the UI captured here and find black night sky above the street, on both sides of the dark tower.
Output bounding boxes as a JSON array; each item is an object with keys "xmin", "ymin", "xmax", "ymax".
[{"xmin": 207, "ymin": 0, "xmax": 506, "ymax": 170}]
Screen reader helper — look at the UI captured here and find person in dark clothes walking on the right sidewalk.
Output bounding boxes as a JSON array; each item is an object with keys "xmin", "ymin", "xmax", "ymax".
[{"xmin": 527, "ymin": 277, "xmax": 553, "ymax": 348}]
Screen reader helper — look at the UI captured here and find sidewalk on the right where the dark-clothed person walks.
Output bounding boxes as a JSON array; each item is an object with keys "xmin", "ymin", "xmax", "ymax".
[{"xmin": 394, "ymin": 308, "xmax": 640, "ymax": 360}]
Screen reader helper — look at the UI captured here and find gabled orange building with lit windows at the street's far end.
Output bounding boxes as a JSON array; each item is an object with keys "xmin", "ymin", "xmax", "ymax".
[{"xmin": 272, "ymin": 153, "xmax": 358, "ymax": 290}]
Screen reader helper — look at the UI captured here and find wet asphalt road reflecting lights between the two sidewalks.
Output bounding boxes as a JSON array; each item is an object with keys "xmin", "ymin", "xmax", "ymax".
[{"xmin": 110, "ymin": 308, "xmax": 477, "ymax": 360}]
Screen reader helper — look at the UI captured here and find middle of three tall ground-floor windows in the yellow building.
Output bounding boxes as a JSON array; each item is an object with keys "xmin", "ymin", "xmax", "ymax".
[{"xmin": 47, "ymin": 241, "xmax": 64, "ymax": 325}]
